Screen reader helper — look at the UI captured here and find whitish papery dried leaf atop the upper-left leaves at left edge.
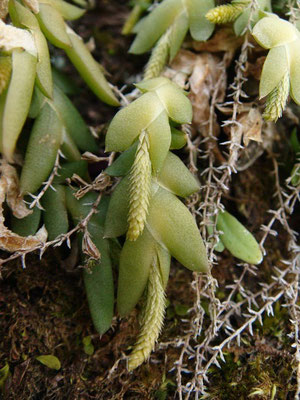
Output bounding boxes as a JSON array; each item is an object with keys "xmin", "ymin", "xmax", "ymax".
[{"xmin": 0, "ymin": 20, "xmax": 37, "ymax": 57}]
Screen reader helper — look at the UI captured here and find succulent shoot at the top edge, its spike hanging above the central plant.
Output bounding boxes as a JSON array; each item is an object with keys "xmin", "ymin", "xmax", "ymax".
[{"xmin": 129, "ymin": 0, "xmax": 214, "ymax": 79}]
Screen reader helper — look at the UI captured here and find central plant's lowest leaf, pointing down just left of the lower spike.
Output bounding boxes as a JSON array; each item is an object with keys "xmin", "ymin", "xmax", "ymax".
[{"xmin": 117, "ymin": 229, "xmax": 155, "ymax": 316}]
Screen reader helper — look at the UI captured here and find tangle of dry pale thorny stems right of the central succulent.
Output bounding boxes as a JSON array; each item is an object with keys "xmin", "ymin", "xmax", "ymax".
[{"xmin": 171, "ymin": 1, "xmax": 300, "ymax": 400}]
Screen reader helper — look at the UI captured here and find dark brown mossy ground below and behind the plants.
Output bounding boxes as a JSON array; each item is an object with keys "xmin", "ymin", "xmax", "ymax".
[{"xmin": 0, "ymin": 0, "xmax": 299, "ymax": 400}]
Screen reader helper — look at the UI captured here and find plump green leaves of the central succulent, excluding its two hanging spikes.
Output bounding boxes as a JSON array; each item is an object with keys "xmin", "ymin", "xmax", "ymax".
[{"xmin": 104, "ymin": 78, "xmax": 208, "ymax": 315}]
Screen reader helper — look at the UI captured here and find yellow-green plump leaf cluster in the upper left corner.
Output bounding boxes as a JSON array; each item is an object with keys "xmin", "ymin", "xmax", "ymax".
[{"xmin": 0, "ymin": 0, "xmax": 118, "ymax": 161}]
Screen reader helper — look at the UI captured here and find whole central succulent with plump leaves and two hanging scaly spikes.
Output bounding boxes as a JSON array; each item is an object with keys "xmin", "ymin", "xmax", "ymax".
[{"xmin": 104, "ymin": 78, "xmax": 208, "ymax": 370}]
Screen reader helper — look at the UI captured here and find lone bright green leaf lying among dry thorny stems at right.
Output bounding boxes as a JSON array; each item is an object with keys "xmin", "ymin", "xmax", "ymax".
[{"xmin": 217, "ymin": 211, "xmax": 263, "ymax": 264}]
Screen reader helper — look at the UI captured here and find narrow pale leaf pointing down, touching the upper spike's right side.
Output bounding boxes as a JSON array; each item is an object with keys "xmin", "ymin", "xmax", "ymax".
[{"xmin": 147, "ymin": 112, "xmax": 171, "ymax": 174}]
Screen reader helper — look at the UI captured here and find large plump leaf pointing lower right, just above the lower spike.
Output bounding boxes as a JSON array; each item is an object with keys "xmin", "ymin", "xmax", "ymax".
[{"xmin": 147, "ymin": 188, "xmax": 208, "ymax": 272}]
